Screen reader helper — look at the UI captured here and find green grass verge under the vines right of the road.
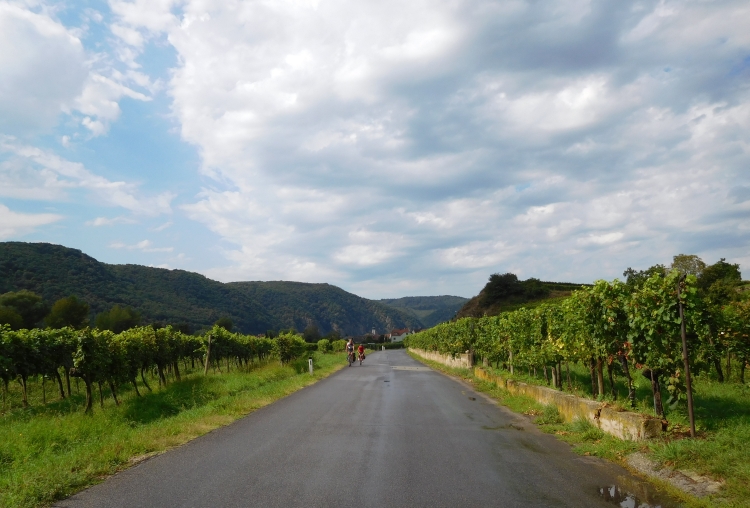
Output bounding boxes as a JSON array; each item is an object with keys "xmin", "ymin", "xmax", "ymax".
[{"xmin": 410, "ymin": 353, "xmax": 750, "ymax": 507}]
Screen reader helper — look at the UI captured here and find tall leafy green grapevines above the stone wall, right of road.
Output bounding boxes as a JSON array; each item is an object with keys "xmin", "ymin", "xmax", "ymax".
[{"xmin": 406, "ymin": 255, "xmax": 750, "ymax": 416}]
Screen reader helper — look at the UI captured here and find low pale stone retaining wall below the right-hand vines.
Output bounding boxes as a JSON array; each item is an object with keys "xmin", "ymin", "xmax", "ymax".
[{"xmin": 409, "ymin": 348, "xmax": 661, "ymax": 441}]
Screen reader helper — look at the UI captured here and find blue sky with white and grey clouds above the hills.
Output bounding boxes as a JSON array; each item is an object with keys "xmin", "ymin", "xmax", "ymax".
[{"xmin": 0, "ymin": 0, "xmax": 750, "ymax": 298}]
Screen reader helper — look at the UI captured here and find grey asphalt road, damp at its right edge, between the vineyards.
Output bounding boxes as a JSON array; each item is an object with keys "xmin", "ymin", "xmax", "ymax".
[{"xmin": 57, "ymin": 350, "xmax": 673, "ymax": 508}]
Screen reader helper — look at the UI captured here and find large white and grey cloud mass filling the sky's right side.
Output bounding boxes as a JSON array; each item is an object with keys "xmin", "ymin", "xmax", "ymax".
[{"xmin": 30, "ymin": 0, "xmax": 750, "ymax": 296}]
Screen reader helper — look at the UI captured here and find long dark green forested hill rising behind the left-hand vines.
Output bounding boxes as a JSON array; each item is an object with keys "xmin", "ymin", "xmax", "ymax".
[{"xmin": 0, "ymin": 242, "xmax": 422, "ymax": 335}]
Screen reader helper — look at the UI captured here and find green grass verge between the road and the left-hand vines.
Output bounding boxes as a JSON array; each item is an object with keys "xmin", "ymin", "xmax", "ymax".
[{"xmin": 0, "ymin": 354, "xmax": 346, "ymax": 507}]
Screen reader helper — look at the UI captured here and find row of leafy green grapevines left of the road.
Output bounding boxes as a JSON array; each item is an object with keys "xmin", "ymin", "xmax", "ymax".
[{"xmin": 0, "ymin": 325, "xmax": 309, "ymax": 412}]
